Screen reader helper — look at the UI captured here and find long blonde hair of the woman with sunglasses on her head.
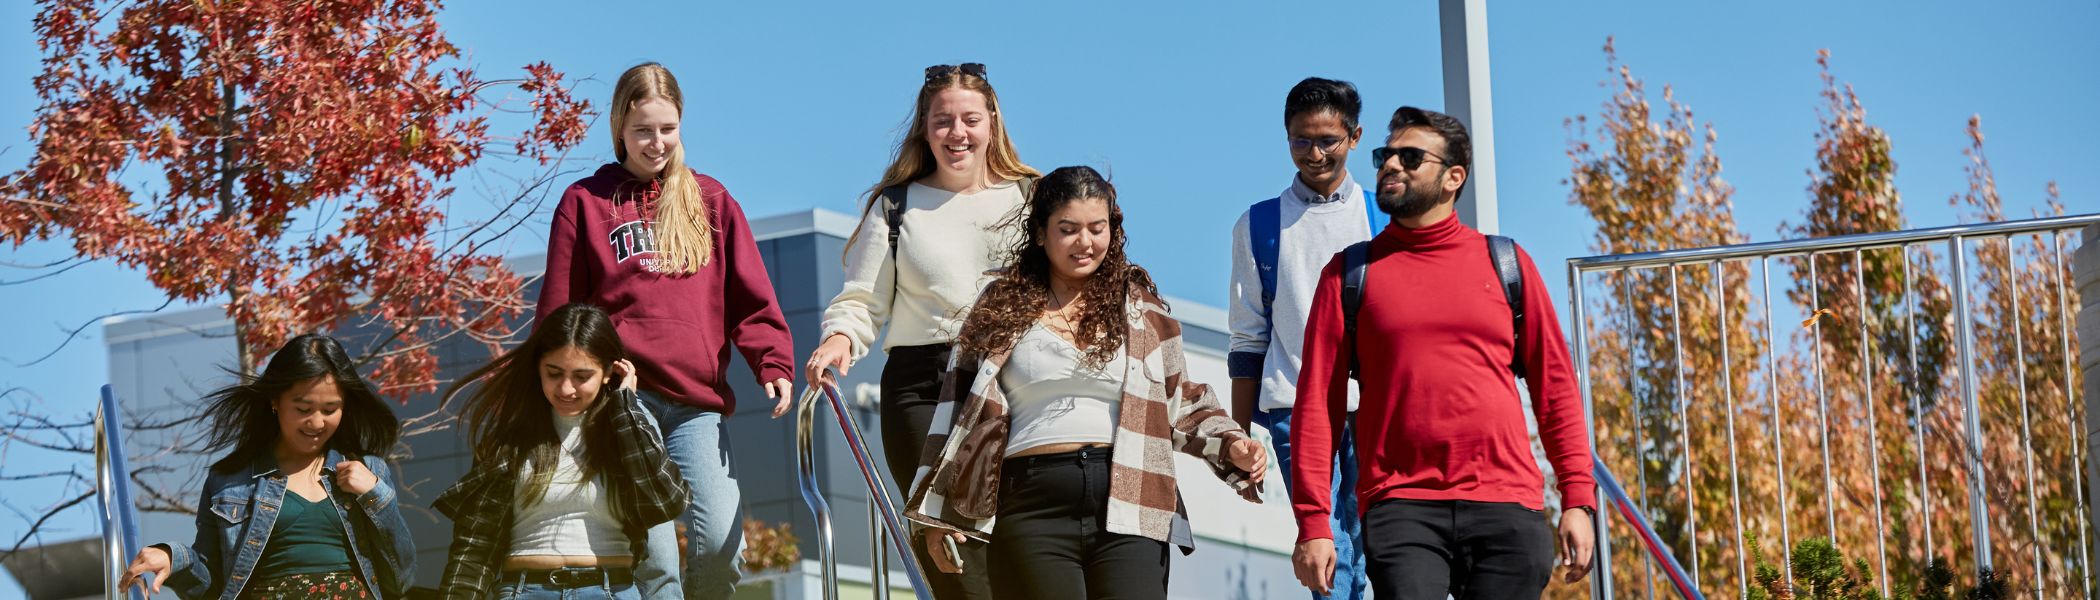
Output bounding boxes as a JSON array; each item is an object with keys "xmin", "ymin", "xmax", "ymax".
[{"xmin": 846, "ymin": 69, "xmax": 1042, "ymax": 258}]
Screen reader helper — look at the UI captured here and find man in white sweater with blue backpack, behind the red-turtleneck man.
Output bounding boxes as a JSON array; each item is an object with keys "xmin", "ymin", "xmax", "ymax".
[{"xmin": 1226, "ymin": 78, "xmax": 1384, "ymax": 600}]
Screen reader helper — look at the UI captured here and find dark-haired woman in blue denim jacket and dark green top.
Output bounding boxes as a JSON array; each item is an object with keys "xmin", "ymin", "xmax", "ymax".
[{"xmin": 120, "ymin": 334, "xmax": 416, "ymax": 600}]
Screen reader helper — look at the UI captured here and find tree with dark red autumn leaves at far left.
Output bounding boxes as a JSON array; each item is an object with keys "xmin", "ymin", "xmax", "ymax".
[{"xmin": 0, "ymin": 0, "xmax": 588, "ymax": 399}]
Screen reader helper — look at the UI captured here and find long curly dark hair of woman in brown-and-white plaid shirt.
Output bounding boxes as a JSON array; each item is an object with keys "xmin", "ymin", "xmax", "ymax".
[{"xmin": 956, "ymin": 166, "xmax": 1159, "ymax": 369}]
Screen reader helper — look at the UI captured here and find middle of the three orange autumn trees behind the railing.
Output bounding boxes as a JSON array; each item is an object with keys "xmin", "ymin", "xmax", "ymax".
[{"xmin": 1764, "ymin": 50, "xmax": 1968, "ymax": 592}]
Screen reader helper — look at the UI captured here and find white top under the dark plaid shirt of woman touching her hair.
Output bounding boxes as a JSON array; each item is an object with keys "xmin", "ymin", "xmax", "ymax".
[{"xmin": 510, "ymin": 415, "xmax": 634, "ymax": 556}]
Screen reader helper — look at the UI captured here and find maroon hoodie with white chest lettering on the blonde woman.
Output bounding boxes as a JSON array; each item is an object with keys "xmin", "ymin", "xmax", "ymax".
[{"xmin": 538, "ymin": 164, "xmax": 794, "ymax": 413}]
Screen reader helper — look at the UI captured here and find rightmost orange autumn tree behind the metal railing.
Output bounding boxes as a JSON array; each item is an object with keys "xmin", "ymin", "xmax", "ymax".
[{"xmin": 1943, "ymin": 115, "xmax": 2090, "ymax": 598}]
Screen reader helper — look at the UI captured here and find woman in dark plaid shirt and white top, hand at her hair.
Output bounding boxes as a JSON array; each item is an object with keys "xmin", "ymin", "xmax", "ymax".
[{"xmin": 437, "ymin": 304, "xmax": 687, "ymax": 600}]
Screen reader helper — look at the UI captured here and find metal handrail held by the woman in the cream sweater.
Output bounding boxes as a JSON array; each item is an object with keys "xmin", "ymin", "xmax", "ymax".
[{"xmin": 794, "ymin": 375, "xmax": 932, "ymax": 600}]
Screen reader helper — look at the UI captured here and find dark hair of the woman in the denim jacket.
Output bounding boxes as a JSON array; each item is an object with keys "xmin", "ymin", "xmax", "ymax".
[{"xmin": 204, "ymin": 334, "xmax": 401, "ymax": 472}]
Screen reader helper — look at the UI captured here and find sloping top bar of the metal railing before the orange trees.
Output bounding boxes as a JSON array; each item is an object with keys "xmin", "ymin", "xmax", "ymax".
[{"xmin": 1569, "ymin": 214, "xmax": 2100, "ymax": 273}]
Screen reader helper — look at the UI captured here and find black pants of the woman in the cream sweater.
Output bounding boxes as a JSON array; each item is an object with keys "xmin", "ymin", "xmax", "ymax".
[{"xmin": 882, "ymin": 344, "xmax": 991, "ymax": 600}]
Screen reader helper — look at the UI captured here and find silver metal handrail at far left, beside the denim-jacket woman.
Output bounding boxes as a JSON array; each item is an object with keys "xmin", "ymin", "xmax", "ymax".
[{"xmin": 95, "ymin": 386, "xmax": 153, "ymax": 600}]
